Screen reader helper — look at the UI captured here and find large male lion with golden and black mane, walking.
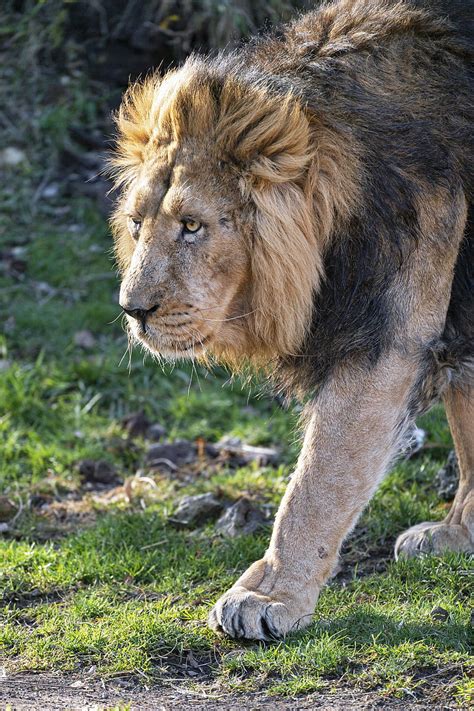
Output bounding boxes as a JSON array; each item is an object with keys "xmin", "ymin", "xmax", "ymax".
[{"xmin": 112, "ymin": 0, "xmax": 474, "ymax": 640}]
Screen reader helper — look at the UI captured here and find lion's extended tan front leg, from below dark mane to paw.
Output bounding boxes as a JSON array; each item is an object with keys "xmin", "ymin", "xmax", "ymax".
[{"xmin": 209, "ymin": 354, "xmax": 417, "ymax": 639}]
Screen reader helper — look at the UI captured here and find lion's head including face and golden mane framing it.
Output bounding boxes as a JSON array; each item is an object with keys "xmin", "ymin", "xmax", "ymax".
[{"xmin": 109, "ymin": 58, "xmax": 344, "ymax": 362}]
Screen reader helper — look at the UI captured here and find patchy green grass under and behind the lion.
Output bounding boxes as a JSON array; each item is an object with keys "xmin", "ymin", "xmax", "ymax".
[{"xmin": 0, "ymin": 4, "xmax": 473, "ymax": 707}]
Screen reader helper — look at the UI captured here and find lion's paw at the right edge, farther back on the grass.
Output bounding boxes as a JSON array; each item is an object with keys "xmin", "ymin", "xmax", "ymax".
[{"xmin": 395, "ymin": 522, "xmax": 474, "ymax": 560}]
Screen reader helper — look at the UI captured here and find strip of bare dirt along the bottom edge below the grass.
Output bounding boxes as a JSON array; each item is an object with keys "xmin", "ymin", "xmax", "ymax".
[{"xmin": 0, "ymin": 674, "xmax": 455, "ymax": 711}]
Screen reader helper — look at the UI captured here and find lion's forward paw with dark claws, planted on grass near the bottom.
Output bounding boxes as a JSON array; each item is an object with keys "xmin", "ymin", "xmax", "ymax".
[{"xmin": 209, "ymin": 587, "xmax": 312, "ymax": 641}]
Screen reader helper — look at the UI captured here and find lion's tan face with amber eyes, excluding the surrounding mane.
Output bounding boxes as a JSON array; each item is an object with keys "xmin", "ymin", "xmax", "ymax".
[{"xmin": 120, "ymin": 144, "xmax": 250, "ymax": 358}]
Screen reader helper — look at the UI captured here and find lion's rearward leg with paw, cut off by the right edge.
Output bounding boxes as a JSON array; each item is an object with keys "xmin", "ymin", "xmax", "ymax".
[{"xmin": 395, "ymin": 386, "xmax": 474, "ymax": 558}]
